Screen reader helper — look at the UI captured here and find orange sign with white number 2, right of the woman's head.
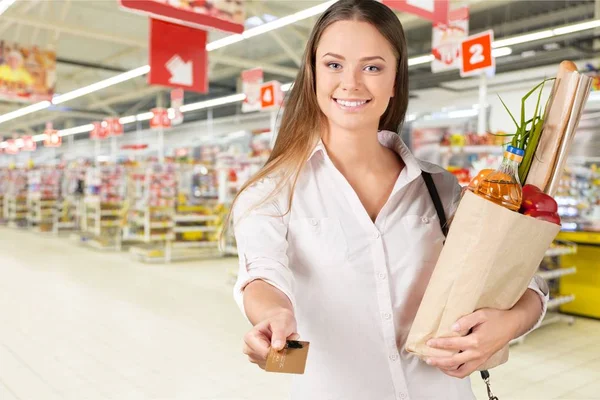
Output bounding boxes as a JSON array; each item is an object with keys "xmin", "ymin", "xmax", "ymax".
[{"xmin": 460, "ymin": 30, "xmax": 494, "ymax": 77}]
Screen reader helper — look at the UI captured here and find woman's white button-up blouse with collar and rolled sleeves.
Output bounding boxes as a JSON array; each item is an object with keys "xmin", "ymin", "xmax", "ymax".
[{"xmin": 234, "ymin": 131, "xmax": 548, "ymax": 400}]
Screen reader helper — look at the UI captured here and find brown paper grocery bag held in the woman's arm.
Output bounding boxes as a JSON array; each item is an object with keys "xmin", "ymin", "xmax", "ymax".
[{"xmin": 406, "ymin": 191, "xmax": 560, "ymax": 369}]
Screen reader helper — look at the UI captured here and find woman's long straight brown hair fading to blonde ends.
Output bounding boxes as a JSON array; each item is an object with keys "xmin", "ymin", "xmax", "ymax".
[{"xmin": 224, "ymin": 0, "xmax": 408, "ymax": 231}]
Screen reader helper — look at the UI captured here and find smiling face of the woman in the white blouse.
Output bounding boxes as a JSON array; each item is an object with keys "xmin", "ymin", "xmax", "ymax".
[{"xmin": 315, "ymin": 21, "xmax": 397, "ymax": 131}]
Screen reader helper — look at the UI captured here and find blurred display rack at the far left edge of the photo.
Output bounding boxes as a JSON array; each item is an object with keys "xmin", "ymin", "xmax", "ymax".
[{"xmin": 4, "ymin": 169, "xmax": 28, "ymax": 228}]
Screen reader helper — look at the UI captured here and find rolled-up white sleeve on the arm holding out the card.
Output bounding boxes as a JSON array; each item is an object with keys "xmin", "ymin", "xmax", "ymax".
[{"xmin": 233, "ymin": 179, "xmax": 296, "ymax": 318}]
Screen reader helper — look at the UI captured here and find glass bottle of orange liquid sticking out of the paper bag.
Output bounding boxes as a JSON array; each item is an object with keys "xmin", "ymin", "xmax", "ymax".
[{"xmin": 474, "ymin": 146, "xmax": 525, "ymax": 211}]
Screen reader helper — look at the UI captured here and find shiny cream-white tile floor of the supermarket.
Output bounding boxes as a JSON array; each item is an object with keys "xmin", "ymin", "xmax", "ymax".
[{"xmin": 0, "ymin": 228, "xmax": 600, "ymax": 400}]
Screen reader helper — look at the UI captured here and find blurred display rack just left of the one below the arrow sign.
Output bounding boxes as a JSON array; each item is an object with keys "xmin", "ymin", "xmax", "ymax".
[{"xmin": 81, "ymin": 165, "xmax": 127, "ymax": 250}]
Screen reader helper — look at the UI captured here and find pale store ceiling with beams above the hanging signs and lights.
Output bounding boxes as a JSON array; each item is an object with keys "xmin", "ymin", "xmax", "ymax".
[{"xmin": 0, "ymin": 0, "xmax": 597, "ymax": 133}]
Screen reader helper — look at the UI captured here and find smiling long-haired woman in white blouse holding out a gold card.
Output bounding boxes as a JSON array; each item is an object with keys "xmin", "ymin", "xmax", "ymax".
[{"xmin": 233, "ymin": 0, "xmax": 547, "ymax": 400}]
